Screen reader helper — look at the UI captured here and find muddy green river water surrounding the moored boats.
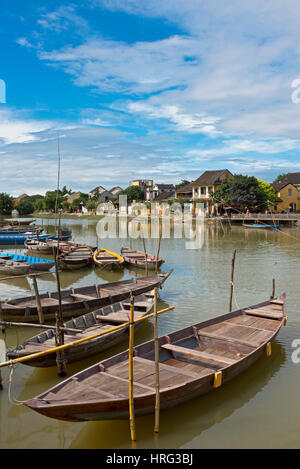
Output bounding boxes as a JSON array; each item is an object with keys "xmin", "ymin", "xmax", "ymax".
[{"xmin": 0, "ymin": 220, "xmax": 300, "ymax": 449}]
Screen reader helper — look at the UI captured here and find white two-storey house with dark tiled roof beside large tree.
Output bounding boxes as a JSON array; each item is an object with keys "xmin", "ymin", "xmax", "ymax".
[{"xmin": 191, "ymin": 169, "xmax": 233, "ymax": 215}]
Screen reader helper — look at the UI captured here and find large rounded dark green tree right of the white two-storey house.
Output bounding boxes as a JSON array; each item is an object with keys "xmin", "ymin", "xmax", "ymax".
[{"xmin": 212, "ymin": 174, "xmax": 267, "ymax": 209}]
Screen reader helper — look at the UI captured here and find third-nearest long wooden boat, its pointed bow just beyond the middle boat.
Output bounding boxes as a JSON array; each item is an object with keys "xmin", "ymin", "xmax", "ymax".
[{"xmin": 0, "ymin": 270, "xmax": 172, "ymax": 322}]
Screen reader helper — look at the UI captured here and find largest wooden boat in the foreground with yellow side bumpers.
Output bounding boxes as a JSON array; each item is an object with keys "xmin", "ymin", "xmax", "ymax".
[{"xmin": 25, "ymin": 294, "xmax": 286, "ymax": 421}]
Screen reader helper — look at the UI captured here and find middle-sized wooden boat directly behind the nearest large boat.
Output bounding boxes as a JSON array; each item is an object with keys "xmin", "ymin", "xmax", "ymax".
[{"xmin": 6, "ymin": 292, "xmax": 154, "ymax": 367}]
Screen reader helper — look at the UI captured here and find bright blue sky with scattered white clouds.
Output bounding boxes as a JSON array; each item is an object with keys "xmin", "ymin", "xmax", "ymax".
[{"xmin": 0, "ymin": 0, "xmax": 300, "ymax": 196}]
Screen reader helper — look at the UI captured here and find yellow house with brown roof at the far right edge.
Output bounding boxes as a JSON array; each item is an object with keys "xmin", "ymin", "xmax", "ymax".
[{"xmin": 271, "ymin": 181, "xmax": 300, "ymax": 213}]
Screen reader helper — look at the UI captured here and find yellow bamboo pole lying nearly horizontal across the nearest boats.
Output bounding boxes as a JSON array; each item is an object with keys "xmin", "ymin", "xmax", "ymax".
[{"xmin": 0, "ymin": 306, "xmax": 175, "ymax": 368}]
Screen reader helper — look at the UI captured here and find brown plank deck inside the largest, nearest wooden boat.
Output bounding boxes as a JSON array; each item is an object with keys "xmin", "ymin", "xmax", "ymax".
[{"xmin": 40, "ymin": 302, "xmax": 283, "ymax": 402}]
